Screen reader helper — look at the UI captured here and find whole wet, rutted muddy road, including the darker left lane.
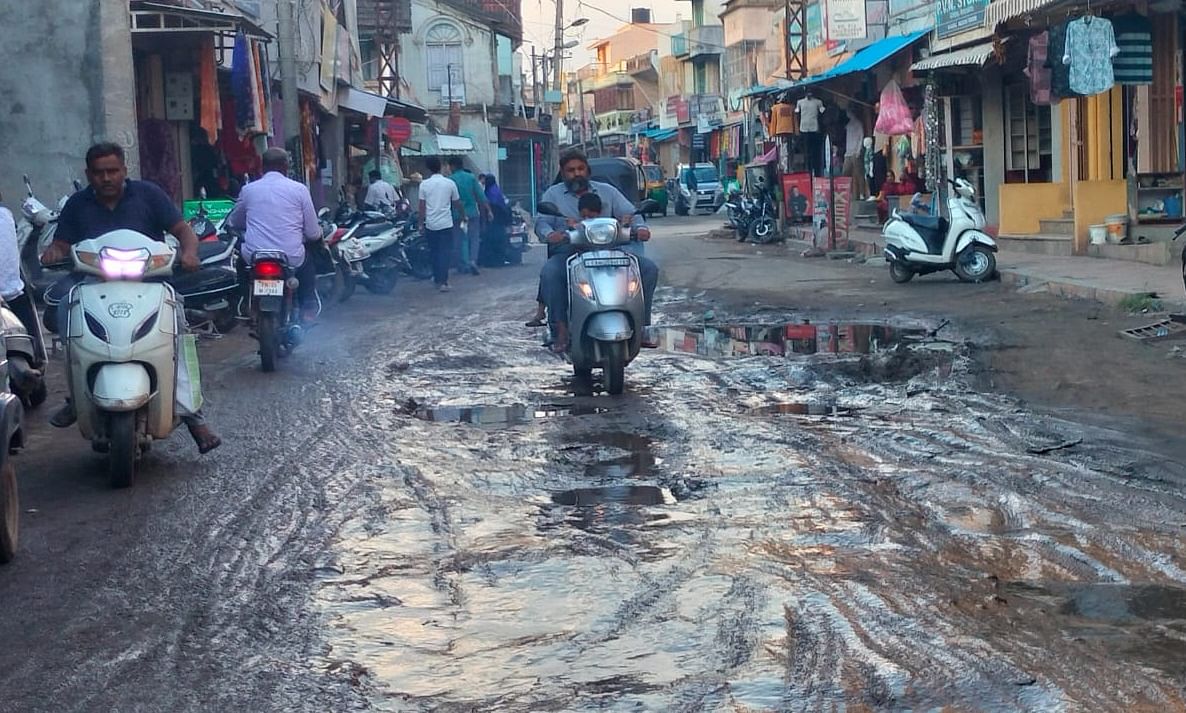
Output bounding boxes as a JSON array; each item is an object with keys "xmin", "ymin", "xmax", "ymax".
[{"xmin": 0, "ymin": 221, "xmax": 1186, "ymax": 712}]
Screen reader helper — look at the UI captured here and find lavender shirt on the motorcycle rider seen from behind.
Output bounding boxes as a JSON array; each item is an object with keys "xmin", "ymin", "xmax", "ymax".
[{"xmin": 227, "ymin": 171, "xmax": 321, "ymax": 267}]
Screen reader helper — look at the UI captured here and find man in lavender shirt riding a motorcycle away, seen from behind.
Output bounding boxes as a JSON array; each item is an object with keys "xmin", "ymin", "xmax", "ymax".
[{"xmin": 227, "ymin": 148, "xmax": 321, "ymax": 322}]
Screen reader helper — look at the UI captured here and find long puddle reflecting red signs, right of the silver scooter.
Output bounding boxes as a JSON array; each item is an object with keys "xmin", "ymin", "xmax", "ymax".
[{"xmin": 659, "ymin": 323, "xmax": 927, "ymax": 357}]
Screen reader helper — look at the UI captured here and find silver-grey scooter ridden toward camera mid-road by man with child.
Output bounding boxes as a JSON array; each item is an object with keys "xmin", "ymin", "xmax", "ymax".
[{"xmin": 538, "ymin": 199, "xmax": 657, "ymax": 395}]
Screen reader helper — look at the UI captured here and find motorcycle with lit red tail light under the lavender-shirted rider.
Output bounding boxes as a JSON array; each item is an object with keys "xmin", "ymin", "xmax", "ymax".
[{"xmin": 247, "ymin": 250, "xmax": 305, "ymax": 373}]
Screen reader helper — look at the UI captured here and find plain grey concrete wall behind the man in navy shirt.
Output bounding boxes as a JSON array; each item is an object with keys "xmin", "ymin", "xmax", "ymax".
[{"xmin": 0, "ymin": 0, "xmax": 139, "ymax": 208}]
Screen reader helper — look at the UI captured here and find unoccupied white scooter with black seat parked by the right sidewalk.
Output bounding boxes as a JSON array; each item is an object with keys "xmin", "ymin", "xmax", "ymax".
[{"xmin": 881, "ymin": 178, "xmax": 996, "ymax": 282}]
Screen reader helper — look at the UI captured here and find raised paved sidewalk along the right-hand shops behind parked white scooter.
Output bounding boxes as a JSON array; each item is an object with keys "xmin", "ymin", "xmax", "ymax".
[{"xmin": 849, "ymin": 229, "xmax": 1186, "ymax": 310}]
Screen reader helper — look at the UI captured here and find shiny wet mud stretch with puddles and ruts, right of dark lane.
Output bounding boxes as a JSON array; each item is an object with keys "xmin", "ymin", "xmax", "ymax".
[{"xmin": 315, "ymin": 295, "xmax": 1186, "ymax": 711}]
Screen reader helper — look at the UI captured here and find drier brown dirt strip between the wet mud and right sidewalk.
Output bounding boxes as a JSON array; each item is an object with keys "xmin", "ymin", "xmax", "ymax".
[{"xmin": 653, "ymin": 230, "xmax": 1186, "ymax": 433}]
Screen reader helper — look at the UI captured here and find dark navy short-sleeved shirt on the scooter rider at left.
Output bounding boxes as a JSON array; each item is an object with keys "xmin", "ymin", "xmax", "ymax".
[{"xmin": 53, "ymin": 180, "xmax": 181, "ymax": 244}]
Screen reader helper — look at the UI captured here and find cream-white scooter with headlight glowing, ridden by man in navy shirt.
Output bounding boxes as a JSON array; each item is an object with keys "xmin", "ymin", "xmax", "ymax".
[{"xmin": 60, "ymin": 230, "xmax": 181, "ymax": 488}]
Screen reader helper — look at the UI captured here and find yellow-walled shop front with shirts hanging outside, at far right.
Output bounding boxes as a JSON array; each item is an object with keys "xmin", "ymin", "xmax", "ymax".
[{"xmin": 986, "ymin": 0, "xmax": 1184, "ymax": 256}]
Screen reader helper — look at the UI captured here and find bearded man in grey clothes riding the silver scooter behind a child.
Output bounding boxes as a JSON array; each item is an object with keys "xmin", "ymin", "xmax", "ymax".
[{"xmin": 535, "ymin": 149, "xmax": 659, "ymax": 354}]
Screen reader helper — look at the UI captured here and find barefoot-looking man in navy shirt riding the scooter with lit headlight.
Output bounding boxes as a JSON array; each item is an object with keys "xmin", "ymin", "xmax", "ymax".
[{"xmin": 42, "ymin": 142, "xmax": 222, "ymax": 453}]
